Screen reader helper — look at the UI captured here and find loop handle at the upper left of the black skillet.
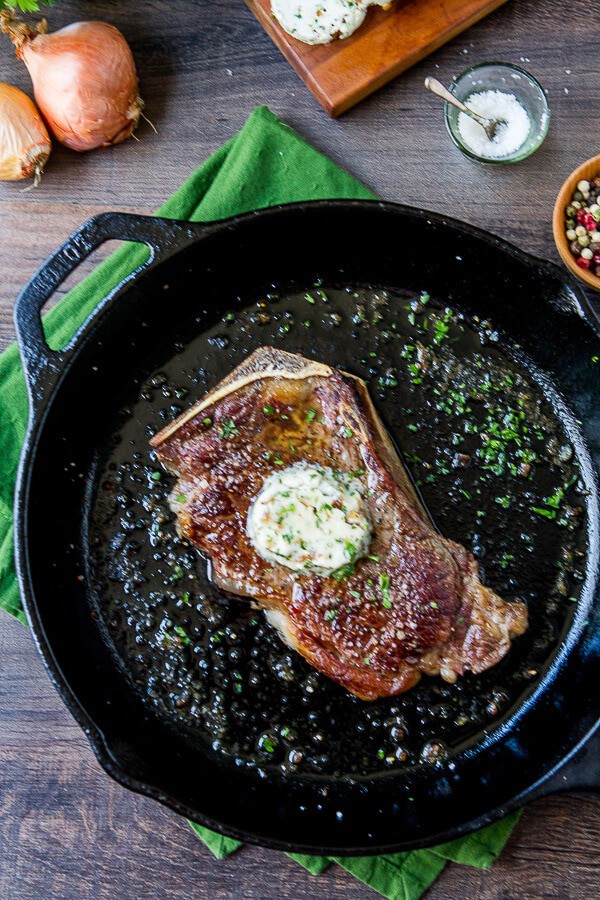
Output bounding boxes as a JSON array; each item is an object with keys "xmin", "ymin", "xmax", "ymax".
[{"xmin": 14, "ymin": 212, "xmax": 195, "ymax": 410}]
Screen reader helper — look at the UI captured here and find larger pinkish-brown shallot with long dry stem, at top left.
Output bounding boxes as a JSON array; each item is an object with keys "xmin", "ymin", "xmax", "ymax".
[{"xmin": 0, "ymin": 12, "xmax": 144, "ymax": 151}]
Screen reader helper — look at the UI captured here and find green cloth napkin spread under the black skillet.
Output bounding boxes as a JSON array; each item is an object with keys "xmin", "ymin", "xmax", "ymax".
[{"xmin": 0, "ymin": 106, "xmax": 519, "ymax": 900}]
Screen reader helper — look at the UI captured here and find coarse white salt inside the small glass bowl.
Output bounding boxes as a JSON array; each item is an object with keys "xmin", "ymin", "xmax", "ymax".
[{"xmin": 458, "ymin": 91, "xmax": 531, "ymax": 159}]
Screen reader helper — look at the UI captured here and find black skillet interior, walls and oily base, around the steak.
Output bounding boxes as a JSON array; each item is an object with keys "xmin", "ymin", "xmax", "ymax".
[{"xmin": 19, "ymin": 205, "xmax": 599, "ymax": 850}]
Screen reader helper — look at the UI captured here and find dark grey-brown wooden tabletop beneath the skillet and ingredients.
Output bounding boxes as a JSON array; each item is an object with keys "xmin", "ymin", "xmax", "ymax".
[{"xmin": 0, "ymin": 0, "xmax": 600, "ymax": 900}]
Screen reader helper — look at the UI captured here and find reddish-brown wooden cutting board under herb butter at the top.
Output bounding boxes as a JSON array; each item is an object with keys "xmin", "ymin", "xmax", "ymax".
[{"xmin": 245, "ymin": 0, "xmax": 506, "ymax": 116}]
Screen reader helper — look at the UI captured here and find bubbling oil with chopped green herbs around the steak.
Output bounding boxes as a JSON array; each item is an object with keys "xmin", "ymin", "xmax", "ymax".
[{"xmin": 90, "ymin": 285, "xmax": 585, "ymax": 775}]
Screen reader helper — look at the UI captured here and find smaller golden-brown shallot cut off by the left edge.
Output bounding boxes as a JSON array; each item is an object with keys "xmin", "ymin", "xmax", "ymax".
[{"xmin": 0, "ymin": 82, "xmax": 52, "ymax": 187}]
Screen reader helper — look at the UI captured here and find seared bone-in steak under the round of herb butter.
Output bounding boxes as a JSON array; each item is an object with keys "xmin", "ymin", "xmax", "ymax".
[{"xmin": 151, "ymin": 347, "xmax": 527, "ymax": 700}]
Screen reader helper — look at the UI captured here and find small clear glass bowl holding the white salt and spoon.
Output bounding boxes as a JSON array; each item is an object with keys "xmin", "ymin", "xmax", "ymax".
[{"xmin": 444, "ymin": 62, "xmax": 550, "ymax": 165}]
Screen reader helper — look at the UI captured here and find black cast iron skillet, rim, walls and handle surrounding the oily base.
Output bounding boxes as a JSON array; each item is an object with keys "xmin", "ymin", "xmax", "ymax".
[{"xmin": 15, "ymin": 201, "xmax": 600, "ymax": 854}]
